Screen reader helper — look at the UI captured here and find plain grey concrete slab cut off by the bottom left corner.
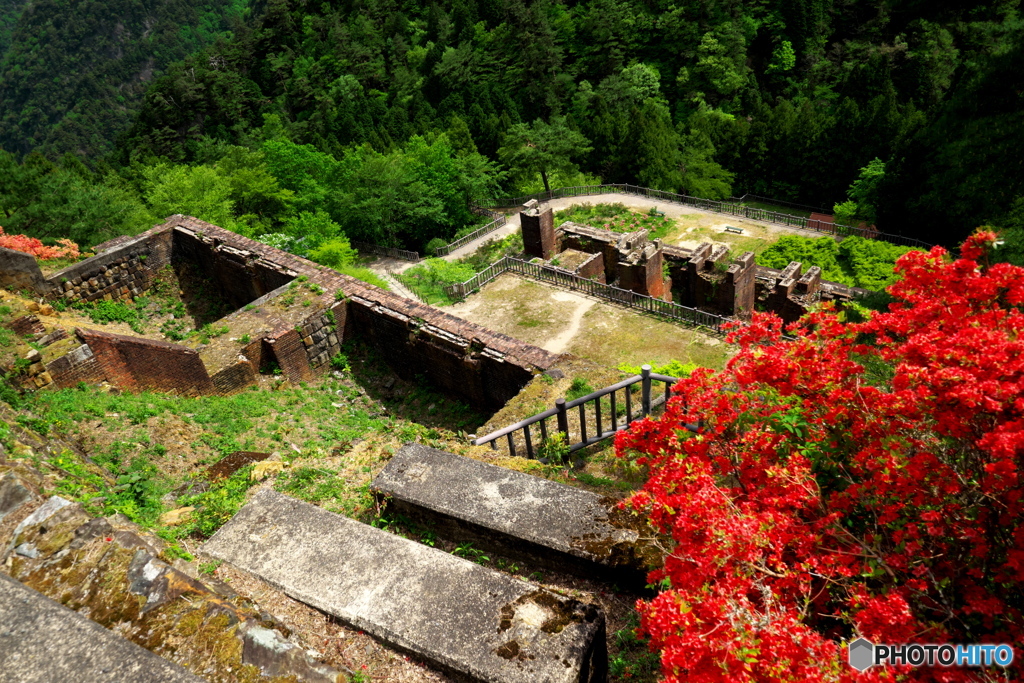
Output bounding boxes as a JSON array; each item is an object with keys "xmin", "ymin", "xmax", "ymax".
[{"xmin": 0, "ymin": 573, "xmax": 203, "ymax": 683}]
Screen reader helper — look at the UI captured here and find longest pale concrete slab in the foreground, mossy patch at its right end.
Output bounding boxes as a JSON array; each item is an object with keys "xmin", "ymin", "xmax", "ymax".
[{"xmin": 203, "ymin": 490, "xmax": 607, "ymax": 683}]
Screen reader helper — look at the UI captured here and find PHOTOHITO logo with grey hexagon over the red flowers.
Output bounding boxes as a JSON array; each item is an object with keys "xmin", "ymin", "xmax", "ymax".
[{"xmin": 847, "ymin": 638, "xmax": 1014, "ymax": 671}]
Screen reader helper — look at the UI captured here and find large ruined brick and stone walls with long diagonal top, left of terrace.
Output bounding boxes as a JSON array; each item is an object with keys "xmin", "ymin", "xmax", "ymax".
[{"xmin": 0, "ymin": 212, "xmax": 559, "ymax": 409}]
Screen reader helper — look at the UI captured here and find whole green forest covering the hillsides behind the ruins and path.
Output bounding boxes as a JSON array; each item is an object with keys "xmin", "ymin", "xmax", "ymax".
[{"xmin": 0, "ymin": 0, "xmax": 1024, "ymax": 256}]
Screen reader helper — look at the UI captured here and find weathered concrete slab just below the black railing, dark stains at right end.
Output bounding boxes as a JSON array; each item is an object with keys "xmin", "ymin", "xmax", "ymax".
[{"xmin": 372, "ymin": 443, "xmax": 663, "ymax": 588}]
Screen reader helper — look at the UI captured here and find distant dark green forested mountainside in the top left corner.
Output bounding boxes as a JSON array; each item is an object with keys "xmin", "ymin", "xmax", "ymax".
[{"xmin": 0, "ymin": 0, "xmax": 247, "ymax": 157}]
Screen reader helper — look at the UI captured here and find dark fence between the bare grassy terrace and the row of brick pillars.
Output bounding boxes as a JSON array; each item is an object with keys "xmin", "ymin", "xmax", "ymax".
[{"xmin": 444, "ymin": 256, "xmax": 733, "ymax": 334}]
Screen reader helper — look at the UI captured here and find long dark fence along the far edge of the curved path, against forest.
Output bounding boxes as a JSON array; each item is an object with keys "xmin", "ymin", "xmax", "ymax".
[{"xmin": 490, "ymin": 183, "xmax": 933, "ymax": 249}]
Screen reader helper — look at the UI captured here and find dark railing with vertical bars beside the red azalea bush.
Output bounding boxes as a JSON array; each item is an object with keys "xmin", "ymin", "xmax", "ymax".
[{"xmin": 473, "ymin": 366, "xmax": 698, "ymax": 459}]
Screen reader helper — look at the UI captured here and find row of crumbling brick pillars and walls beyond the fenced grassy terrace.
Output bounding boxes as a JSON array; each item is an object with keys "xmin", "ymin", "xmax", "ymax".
[{"xmin": 520, "ymin": 204, "xmax": 868, "ymax": 323}]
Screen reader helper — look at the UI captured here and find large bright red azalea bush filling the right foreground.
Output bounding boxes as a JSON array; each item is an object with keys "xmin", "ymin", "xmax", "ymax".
[{"xmin": 615, "ymin": 232, "xmax": 1024, "ymax": 682}]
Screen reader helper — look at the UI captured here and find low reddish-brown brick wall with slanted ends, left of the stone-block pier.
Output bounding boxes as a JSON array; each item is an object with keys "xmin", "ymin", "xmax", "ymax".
[{"xmin": 76, "ymin": 329, "xmax": 214, "ymax": 396}]
